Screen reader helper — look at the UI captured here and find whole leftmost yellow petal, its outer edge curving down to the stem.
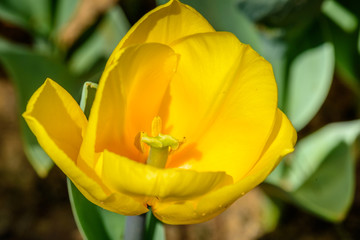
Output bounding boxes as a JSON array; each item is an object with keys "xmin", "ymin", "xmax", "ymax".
[{"xmin": 23, "ymin": 79, "xmax": 147, "ymax": 214}]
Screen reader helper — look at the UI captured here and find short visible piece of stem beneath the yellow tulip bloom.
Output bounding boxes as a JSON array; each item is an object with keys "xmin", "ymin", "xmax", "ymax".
[{"xmin": 124, "ymin": 214, "xmax": 146, "ymax": 240}]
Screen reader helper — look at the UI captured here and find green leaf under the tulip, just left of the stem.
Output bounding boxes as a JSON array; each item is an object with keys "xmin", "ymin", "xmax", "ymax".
[{"xmin": 67, "ymin": 179, "xmax": 125, "ymax": 240}]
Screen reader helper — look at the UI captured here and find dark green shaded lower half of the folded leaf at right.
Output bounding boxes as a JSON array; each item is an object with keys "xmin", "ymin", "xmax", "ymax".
[{"xmin": 292, "ymin": 142, "xmax": 355, "ymax": 221}]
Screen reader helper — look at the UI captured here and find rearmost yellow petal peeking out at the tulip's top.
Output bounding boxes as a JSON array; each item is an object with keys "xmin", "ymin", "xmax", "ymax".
[{"xmin": 108, "ymin": 0, "xmax": 215, "ymax": 65}]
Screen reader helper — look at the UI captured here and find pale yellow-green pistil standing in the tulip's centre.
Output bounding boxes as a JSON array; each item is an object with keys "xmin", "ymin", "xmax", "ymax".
[{"xmin": 135, "ymin": 116, "xmax": 181, "ymax": 168}]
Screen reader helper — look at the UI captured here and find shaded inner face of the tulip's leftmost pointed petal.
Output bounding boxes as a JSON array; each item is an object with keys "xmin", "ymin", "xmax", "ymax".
[{"xmin": 23, "ymin": 79, "xmax": 87, "ymax": 161}]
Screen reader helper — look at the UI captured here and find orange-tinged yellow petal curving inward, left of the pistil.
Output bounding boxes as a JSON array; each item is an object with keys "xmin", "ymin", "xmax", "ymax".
[{"xmin": 80, "ymin": 43, "xmax": 178, "ymax": 167}]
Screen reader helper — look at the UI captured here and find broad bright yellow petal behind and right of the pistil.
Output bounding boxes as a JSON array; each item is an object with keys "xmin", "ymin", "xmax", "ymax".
[{"xmin": 163, "ymin": 32, "xmax": 277, "ymax": 181}]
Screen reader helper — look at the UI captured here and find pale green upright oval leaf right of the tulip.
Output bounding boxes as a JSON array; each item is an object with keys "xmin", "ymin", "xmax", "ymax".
[{"xmin": 284, "ymin": 42, "xmax": 335, "ymax": 131}]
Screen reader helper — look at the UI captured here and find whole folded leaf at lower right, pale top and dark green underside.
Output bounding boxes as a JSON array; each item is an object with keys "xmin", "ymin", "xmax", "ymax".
[{"xmin": 267, "ymin": 120, "xmax": 360, "ymax": 221}]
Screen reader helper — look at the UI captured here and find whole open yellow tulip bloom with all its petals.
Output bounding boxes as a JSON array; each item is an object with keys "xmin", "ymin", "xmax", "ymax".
[{"xmin": 23, "ymin": 0, "xmax": 296, "ymax": 224}]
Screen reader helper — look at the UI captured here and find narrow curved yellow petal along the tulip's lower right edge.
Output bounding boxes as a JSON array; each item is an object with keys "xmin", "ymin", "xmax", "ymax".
[{"xmin": 152, "ymin": 110, "xmax": 296, "ymax": 224}]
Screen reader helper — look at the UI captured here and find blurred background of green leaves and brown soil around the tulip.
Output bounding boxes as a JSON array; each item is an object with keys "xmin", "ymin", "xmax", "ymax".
[{"xmin": 0, "ymin": 0, "xmax": 360, "ymax": 240}]
